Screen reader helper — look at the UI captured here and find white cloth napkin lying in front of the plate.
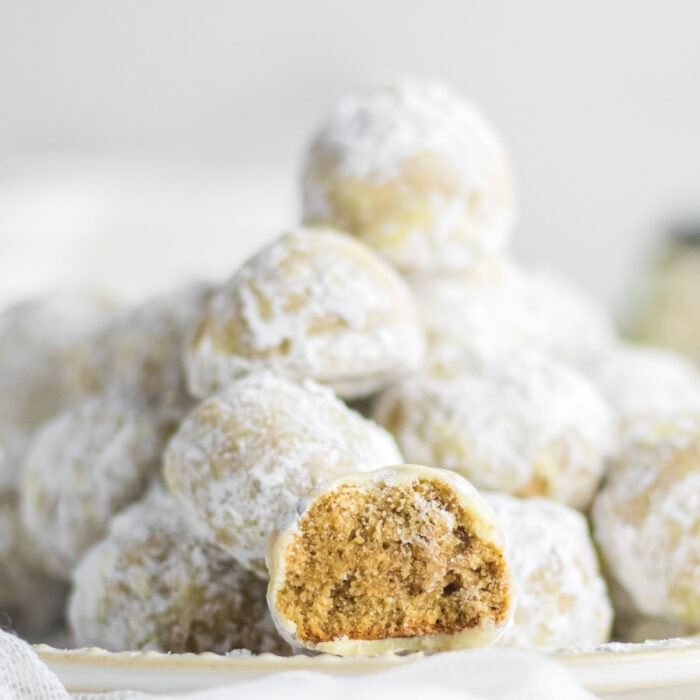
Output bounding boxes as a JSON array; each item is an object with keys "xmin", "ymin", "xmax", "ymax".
[{"xmin": 0, "ymin": 631, "xmax": 594, "ymax": 700}]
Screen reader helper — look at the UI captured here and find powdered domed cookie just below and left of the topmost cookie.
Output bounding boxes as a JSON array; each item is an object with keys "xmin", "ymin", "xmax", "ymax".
[{"xmin": 187, "ymin": 229, "xmax": 424, "ymax": 398}]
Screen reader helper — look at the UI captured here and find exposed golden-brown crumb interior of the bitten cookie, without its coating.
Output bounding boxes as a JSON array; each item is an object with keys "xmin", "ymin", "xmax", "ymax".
[{"xmin": 276, "ymin": 479, "xmax": 511, "ymax": 644}]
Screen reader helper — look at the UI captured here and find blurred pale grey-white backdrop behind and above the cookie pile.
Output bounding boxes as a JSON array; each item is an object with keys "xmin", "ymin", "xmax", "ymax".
[{"xmin": 0, "ymin": 0, "xmax": 700, "ymax": 310}]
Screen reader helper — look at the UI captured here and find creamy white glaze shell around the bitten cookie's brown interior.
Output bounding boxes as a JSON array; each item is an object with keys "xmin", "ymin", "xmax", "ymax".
[{"xmin": 266, "ymin": 464, "xmax": 515, "ymax": 656}]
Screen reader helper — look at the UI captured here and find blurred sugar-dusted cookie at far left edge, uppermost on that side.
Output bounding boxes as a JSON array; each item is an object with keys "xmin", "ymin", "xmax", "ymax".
[{"xmin": 0, "ymin": 292, "xmax": 108, "ymax": 449}]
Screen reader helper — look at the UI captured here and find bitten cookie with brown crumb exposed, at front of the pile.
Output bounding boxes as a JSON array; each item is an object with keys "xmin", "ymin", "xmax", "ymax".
[{"xmin": 267, "ymin": 465, "xmax": 514, "ymax": 655}]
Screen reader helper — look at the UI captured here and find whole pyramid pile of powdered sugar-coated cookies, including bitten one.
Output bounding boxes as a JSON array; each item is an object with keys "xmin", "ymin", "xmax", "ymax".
[{"xmin": 0, "ymin": 82, "xmax": 700, "ymax": 654}]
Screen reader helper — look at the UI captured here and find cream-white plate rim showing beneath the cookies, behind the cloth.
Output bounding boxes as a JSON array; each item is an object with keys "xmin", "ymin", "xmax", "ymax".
[{"xmin": 35, "ymin": 640, "xmax": 700, "ymax": 700}]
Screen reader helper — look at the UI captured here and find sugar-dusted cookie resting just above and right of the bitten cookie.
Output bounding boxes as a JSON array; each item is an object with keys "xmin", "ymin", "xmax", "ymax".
[{"xmin": 375, "ymin": 353, "xmax": 613, "ymax": 508}]
